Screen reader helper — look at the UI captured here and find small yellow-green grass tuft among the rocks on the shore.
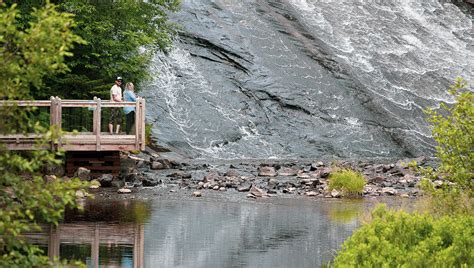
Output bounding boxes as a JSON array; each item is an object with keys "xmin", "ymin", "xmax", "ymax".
[{"xmin": 329, "ymin": 169, "xmax": 367, "ymax": 196}]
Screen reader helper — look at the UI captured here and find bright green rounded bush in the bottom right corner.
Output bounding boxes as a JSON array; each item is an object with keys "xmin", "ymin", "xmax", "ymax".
[{"xmin": 334, "ymin": 205, "xmax": 474, "ymax": 267}]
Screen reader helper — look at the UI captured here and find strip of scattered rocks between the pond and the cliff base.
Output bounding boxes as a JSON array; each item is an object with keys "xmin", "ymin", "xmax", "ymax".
[{"xmin": 71, "ymin": 150, "xmax": 436, "ymax": 199}]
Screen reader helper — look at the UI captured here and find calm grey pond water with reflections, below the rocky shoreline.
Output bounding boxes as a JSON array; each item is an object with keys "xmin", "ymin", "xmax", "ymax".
[{"xmin": 28, "ymin": 199, "xmax": 394, "ymax": 267}]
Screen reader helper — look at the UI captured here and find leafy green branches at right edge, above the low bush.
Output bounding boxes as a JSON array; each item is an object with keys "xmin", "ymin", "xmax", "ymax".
[{"xmin": 426, "ymin": 78, "xmax": 474, "ymax": 193}]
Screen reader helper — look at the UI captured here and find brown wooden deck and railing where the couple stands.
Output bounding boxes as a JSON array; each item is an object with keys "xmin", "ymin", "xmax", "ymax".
[{"xmin": 0, "ymin": 97, "xmax": 145, "ymax": 151}]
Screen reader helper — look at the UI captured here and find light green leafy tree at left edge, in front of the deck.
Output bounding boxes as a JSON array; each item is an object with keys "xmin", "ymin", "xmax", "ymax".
[{"xmin": 0, "ymin": 3, "xmax": 84, "ymax": 267}]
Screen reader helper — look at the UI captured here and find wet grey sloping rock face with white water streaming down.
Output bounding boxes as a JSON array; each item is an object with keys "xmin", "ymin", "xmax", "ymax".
[{"xmin": 142, "ymin": 0, "xmax": 474, "ymax": 158}]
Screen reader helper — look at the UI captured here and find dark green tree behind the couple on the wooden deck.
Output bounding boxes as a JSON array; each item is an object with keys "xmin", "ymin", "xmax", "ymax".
[{"xmin": 7, "ymin": 0, "xmax": 179, "ymax": 99}]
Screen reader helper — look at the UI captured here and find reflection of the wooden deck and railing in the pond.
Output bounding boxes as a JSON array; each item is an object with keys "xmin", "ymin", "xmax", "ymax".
[{"xmin": 26, "ymin": 201, "xmax": 150, "ymax": 268}]
